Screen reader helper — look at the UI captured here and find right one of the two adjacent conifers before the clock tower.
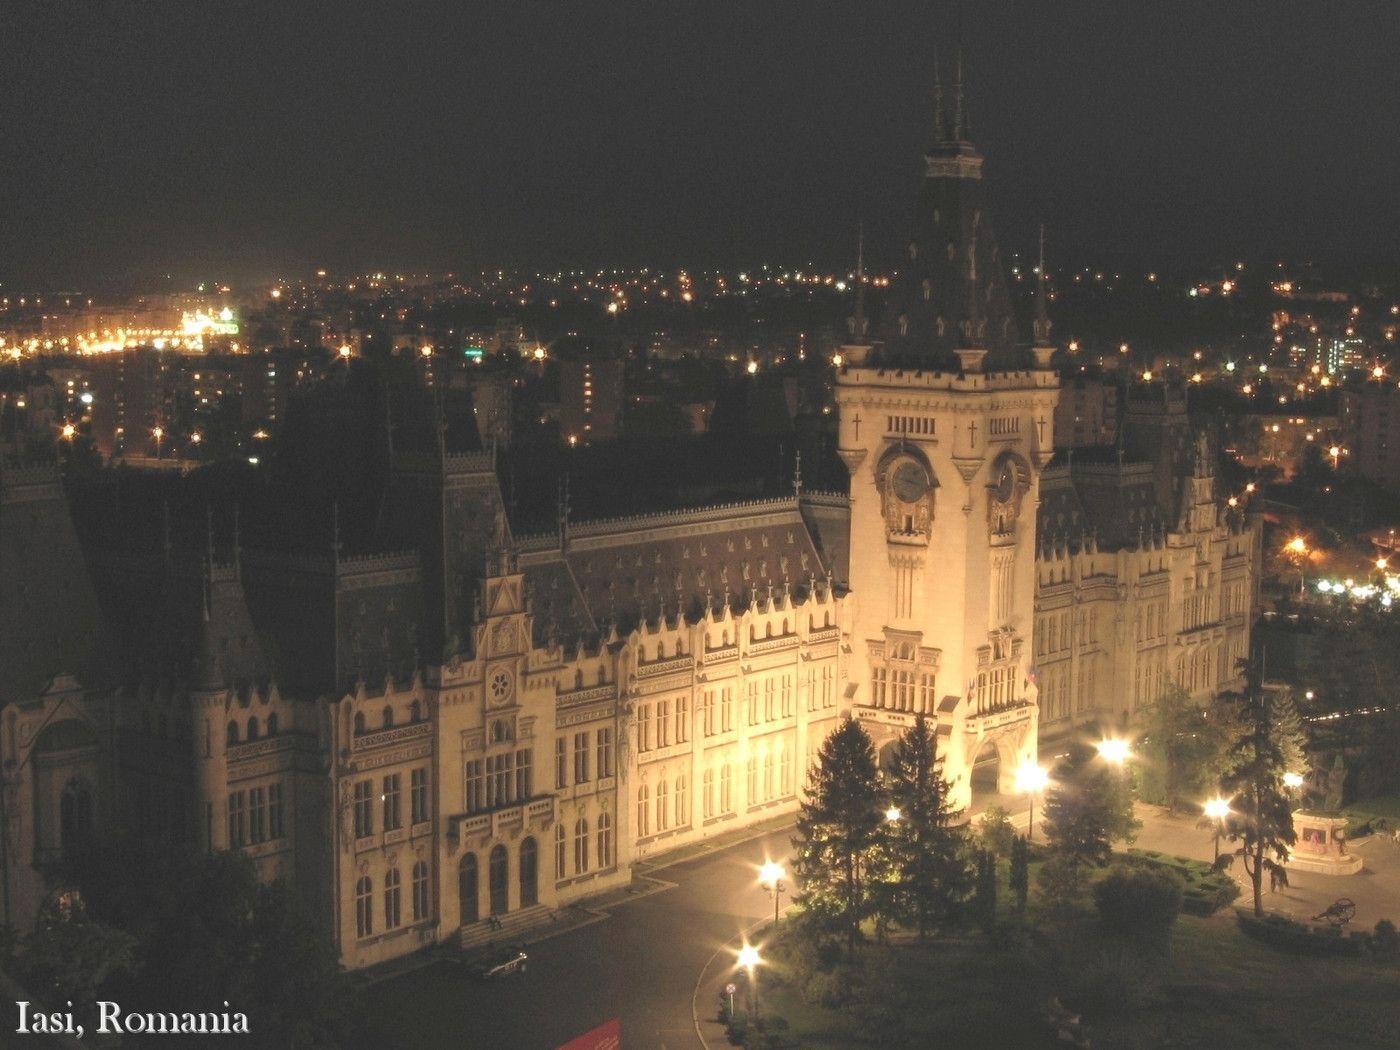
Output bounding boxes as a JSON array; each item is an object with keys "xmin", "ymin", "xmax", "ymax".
[{"xmin": 878, "ymin": 714, "xmax": 973, "ymax": 941}]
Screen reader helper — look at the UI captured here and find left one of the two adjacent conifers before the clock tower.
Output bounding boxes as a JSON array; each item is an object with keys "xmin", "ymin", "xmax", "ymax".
[{"xmin": 792, "ymin": 718, "xmax": 885, "ymax": 949}]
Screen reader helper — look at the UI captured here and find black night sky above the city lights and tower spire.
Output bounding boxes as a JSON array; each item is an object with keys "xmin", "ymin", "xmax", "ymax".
[{"xmin": 0, "ymin": 0, "xmax": 1400, "ymax": 291}]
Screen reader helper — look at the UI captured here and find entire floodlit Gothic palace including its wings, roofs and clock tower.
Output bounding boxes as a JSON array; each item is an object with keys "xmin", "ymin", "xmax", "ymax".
[{"xmin": 0, "ymin": 94, "xmax": 1259, "ymax": 969}]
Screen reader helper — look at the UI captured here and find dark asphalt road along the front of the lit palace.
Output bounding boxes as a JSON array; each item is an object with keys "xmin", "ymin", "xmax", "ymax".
[{"xmin": 363, "ymin": 829, "xmax": 792, "ymax": 1050}]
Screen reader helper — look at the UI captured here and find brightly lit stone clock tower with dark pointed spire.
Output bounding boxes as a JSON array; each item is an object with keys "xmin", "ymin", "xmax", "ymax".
[{"xmin": 836, "ymin": 67, "xmax": 1058, "ymax": 808}]
